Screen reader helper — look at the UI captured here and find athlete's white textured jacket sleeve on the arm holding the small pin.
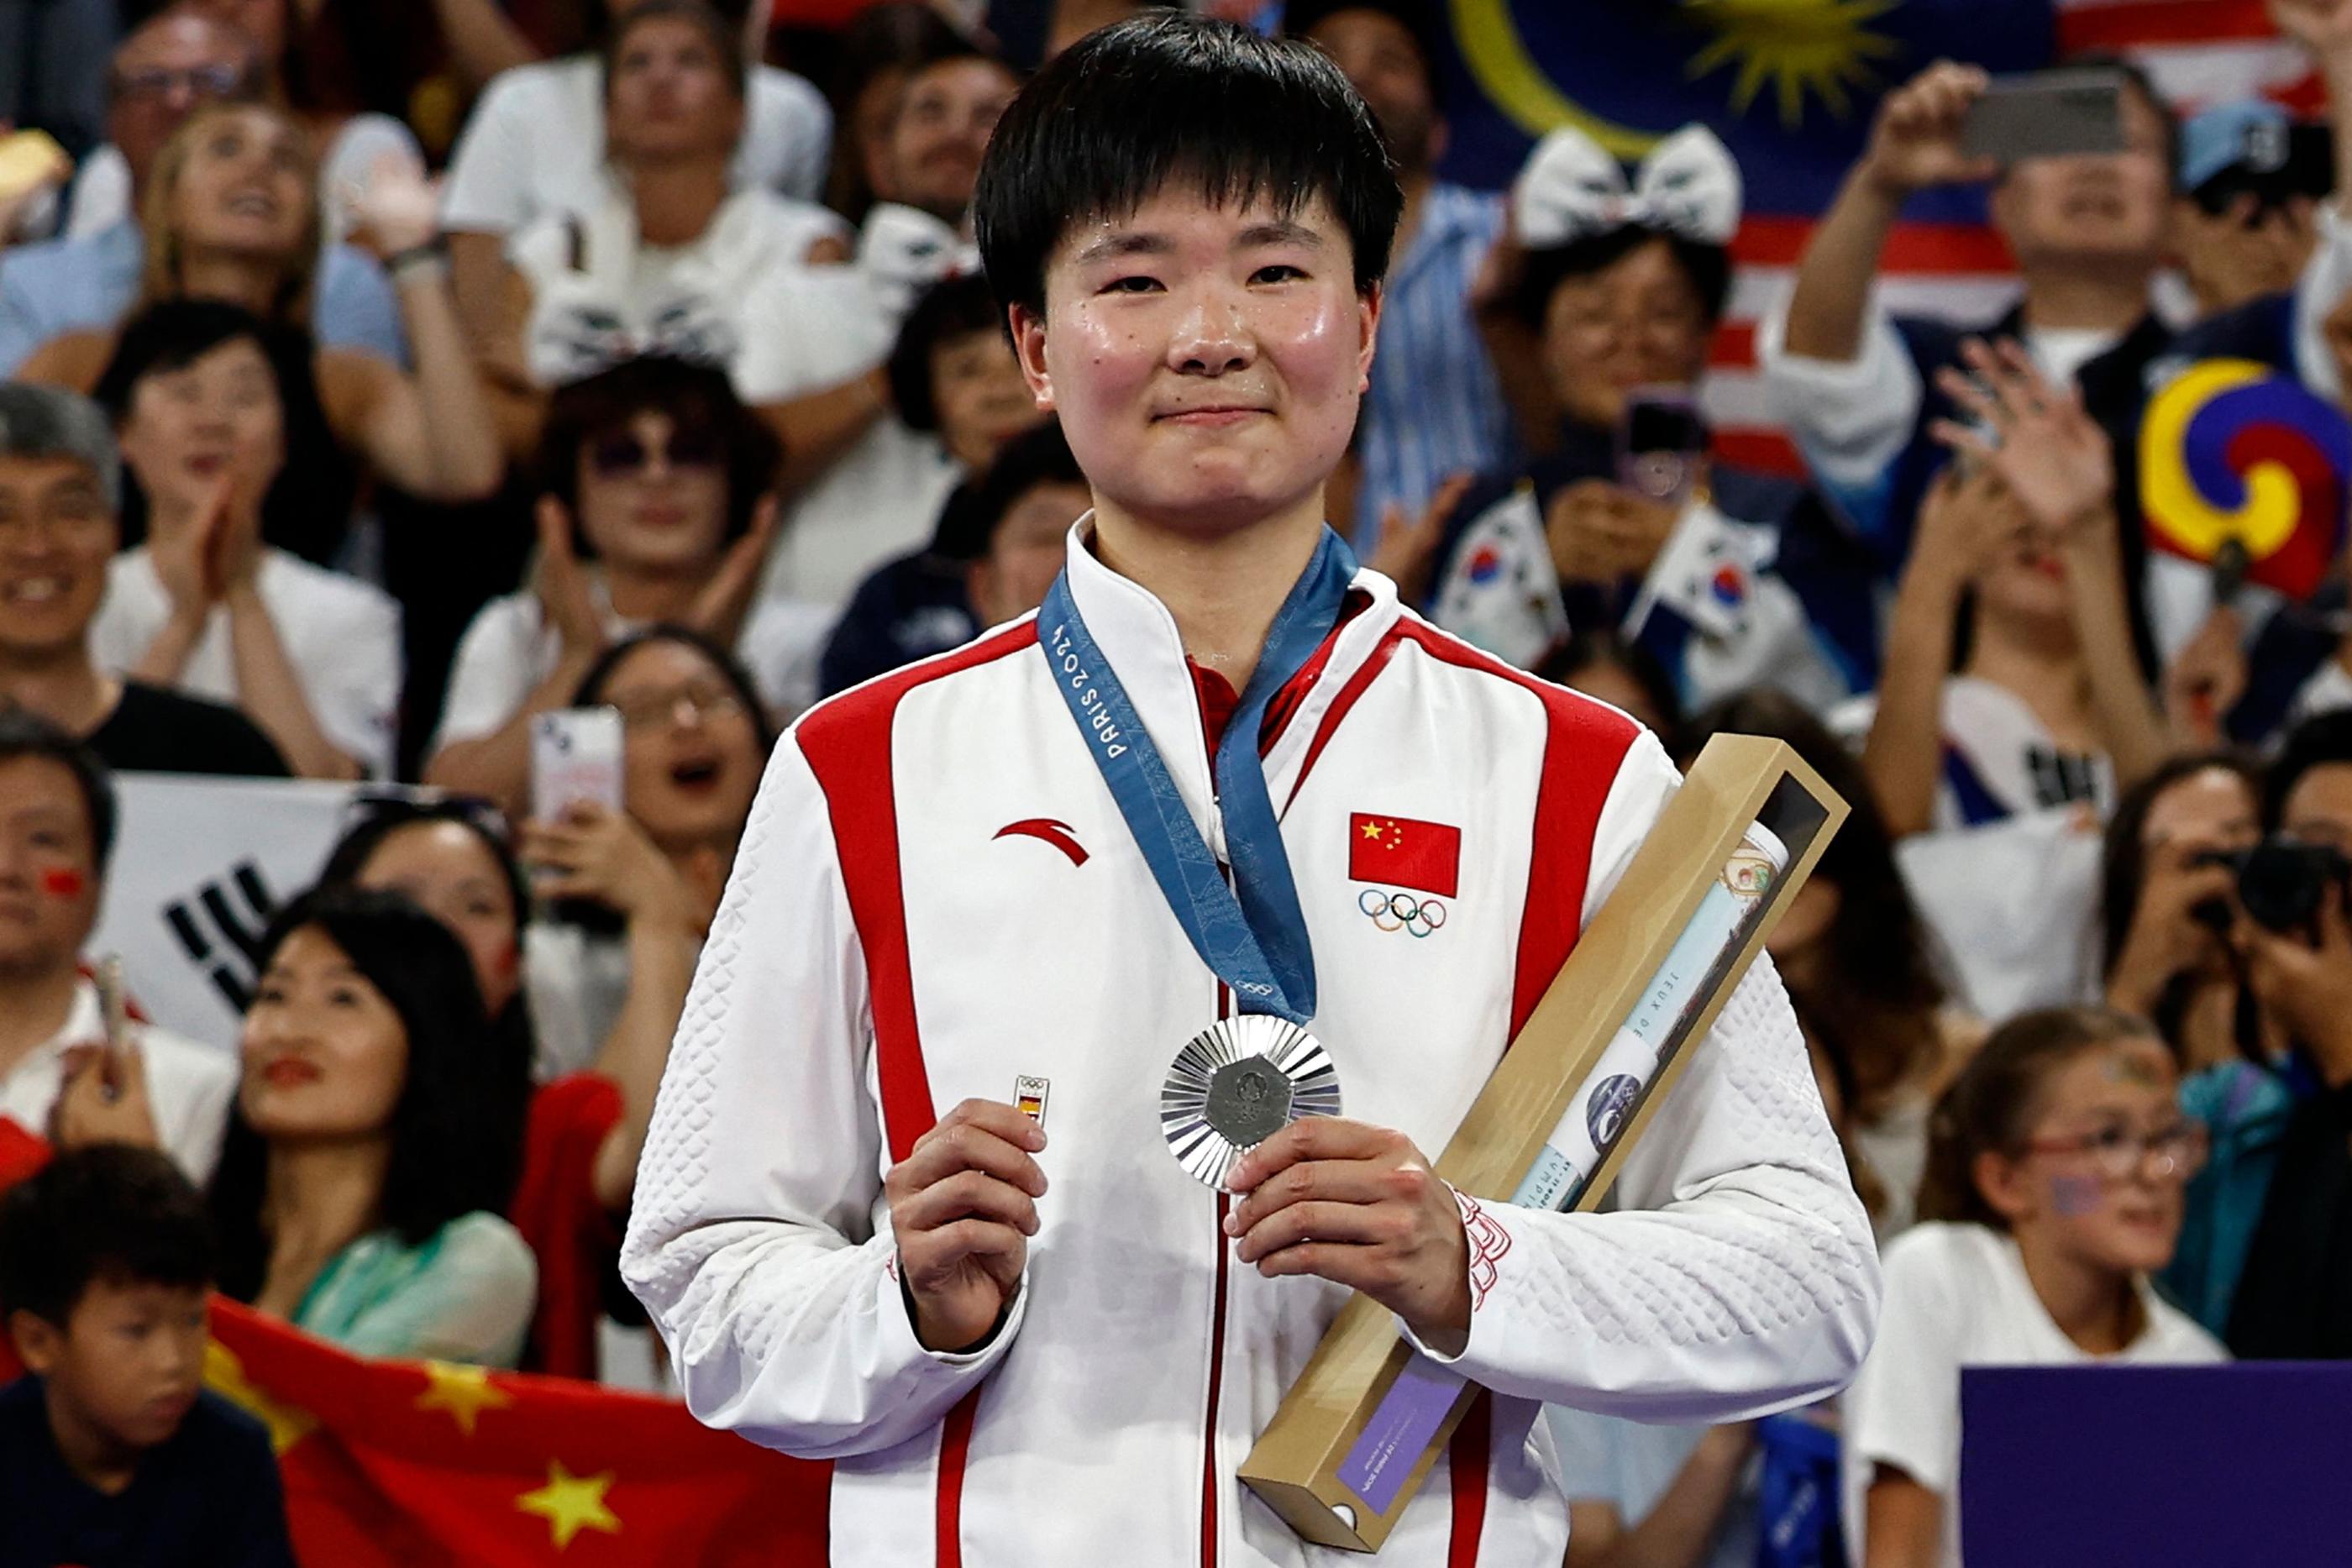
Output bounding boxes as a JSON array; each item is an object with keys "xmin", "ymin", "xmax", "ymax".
[{"xmin": 621, "ymin": 736, "xmax": 1028, "ymax": 1460}]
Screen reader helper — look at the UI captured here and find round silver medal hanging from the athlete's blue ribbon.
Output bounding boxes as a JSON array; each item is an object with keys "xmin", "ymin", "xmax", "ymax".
[{"xmin": 1159, "ymin": 1013, "xmax": 1338, "ymax": 1189}]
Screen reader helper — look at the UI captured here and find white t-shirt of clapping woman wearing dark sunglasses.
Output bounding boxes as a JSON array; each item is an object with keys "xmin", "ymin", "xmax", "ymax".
[{"xmin": 433, "ymin": 580, "xmax": 826, "ymax": 750}]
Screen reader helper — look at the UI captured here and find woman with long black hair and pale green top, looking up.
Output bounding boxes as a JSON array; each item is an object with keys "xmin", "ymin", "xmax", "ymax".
[{"xmin": 212, "ymin": 891, "xmax": 534, "ymax": 1366}]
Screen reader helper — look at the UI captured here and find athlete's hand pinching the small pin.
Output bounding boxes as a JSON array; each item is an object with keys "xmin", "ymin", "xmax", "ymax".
[{"xmin": 882, "ymin": 1100, "xmax": 1044, "ymax": 1354}]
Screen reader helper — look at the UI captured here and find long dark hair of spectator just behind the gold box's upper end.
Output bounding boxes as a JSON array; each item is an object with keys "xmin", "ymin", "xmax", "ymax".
[{"xmin": 1682, "ymin": 686, "xmax": 1945, "ymax": 1121}]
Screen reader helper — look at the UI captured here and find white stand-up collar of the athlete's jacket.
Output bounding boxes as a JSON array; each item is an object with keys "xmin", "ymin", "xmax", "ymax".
[{"xmin": 1063, "ymin": 512, "xmax": 1399, "ymax": 831}]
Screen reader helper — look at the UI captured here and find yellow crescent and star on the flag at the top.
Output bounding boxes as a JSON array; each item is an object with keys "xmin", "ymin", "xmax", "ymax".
[{"xmin": 1449, "ymin": 0, "xmax": 1900, "ymax": 152}]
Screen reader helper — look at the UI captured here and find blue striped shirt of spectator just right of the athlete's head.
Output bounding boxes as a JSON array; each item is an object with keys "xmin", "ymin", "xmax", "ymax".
[{"xmin": 1355, "ymin": 183, "xmax": 1515, "ymax": 550}]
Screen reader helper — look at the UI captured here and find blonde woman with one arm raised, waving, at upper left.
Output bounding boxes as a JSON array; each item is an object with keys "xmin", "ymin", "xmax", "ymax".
[{"xmin": 18, "ymin": 103, "xmax": 503, "ymax": 524}]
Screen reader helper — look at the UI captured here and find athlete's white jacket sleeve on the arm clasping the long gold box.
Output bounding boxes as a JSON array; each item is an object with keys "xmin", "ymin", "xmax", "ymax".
[{"xmin": 1401, "ymin": 732, "xmax": 1879, "ymax": 1422}]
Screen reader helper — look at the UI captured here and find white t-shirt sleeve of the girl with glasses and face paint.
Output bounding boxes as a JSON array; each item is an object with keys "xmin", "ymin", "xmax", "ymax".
[{"xmin": 1841, "ymin": 1225, "xmax": 1964, "ymax": 1492}]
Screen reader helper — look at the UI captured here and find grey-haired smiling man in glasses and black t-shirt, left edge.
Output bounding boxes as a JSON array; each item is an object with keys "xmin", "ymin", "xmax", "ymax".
[{"xmin": 0, "ymin": 383, "xmax": 287, "ymax": 776}]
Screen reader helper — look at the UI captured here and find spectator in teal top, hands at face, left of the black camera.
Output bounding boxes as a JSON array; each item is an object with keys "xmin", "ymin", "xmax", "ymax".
[{"xmin": 2100, "ymin": 753, "xmax": 2293, "ymax": 1335}]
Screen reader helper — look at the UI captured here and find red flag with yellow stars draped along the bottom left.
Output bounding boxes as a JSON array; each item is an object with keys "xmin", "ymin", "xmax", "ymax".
[{"xmin": 0, "ymin": 1119, "xmax": 830, "ymax": 1568}]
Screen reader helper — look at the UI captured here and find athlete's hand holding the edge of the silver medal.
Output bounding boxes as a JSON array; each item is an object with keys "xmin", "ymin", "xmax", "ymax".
[{"xmin": 1226, "ymin": 1117, "xmax": 1470, "ymax": 1345}]
